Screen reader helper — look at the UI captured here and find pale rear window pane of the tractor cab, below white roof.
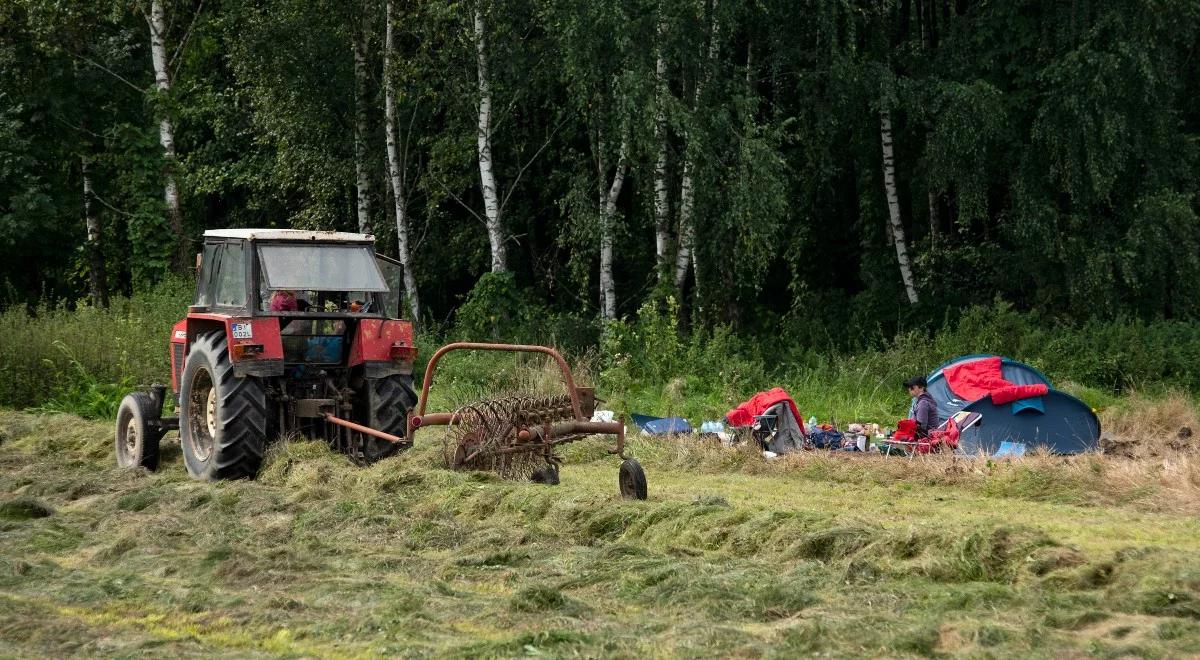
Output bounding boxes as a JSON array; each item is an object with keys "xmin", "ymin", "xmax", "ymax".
[{"xmin": 258, "ymin": 244, "xmax": 388, "ymax": 292}]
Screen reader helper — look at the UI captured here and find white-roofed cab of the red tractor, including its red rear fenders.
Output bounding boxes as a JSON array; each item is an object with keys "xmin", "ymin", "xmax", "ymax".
[{"xmin": 172, "ymin": 229, "xmax": 415, "ymax": 376}]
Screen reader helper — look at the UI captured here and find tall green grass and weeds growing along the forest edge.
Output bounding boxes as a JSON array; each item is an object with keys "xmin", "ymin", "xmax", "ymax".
[{"xmin": 0, "ymin": 281, "xmax": 1200, "ymax": 422}]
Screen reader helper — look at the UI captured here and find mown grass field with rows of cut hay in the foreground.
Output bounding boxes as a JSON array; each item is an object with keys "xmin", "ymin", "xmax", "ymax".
[{"xmin": 0, "ymin": 412, "xmax": 1200, "ymax": 658}]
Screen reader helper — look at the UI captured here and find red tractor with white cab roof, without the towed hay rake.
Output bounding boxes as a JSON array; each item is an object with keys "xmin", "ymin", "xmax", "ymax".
[{"xmin": 116, "ymin": 229, "xmax": 416, "ymax": 479}]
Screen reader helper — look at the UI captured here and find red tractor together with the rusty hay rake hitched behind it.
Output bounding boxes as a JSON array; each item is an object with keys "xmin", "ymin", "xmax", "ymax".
[{"xmin": 116, "ymin": 229, "xmax": 646, "ymax": 499}]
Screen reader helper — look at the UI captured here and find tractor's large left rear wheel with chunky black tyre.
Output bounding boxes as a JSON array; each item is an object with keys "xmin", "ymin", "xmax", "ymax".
[{"xmin": 179, "ymin": 332, "xmax": 268, "ymax": 481}]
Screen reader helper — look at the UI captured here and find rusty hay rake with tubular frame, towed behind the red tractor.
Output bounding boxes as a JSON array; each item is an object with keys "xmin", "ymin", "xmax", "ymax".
[{"xmin": 407, "ymin": 342, "xmax": 646, "ymax": 499}]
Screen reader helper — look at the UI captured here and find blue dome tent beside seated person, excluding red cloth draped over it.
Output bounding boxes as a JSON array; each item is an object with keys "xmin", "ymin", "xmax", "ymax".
[{"xmin": 928, "ymin": 354, "xmax": 1100, "ymax": 455}]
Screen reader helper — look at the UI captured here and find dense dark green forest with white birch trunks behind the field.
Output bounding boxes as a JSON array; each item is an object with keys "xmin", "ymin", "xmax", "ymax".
[{"xmin": 0, "ymin": 0, "xmax": 1200, "ymax": 345}]
